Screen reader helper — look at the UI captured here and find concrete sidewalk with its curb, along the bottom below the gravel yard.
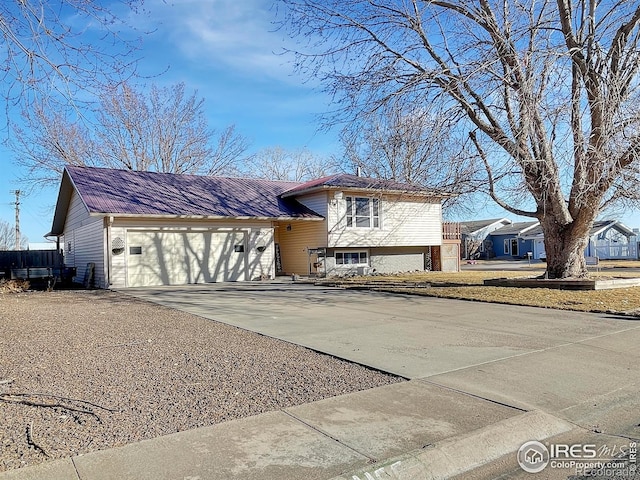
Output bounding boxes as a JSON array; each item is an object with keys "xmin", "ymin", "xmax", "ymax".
[{"xmin": 0, "ymin": 381, "xmax": 573, "ymax": 480}]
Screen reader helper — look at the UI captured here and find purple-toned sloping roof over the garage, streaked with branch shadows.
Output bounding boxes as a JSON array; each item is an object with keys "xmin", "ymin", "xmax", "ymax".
[{"xmin": 66, "ymin": 167, "xmax": 322, "ymax": 219}]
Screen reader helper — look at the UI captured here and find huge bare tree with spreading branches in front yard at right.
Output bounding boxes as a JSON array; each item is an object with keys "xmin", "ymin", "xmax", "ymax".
[{"xmin": 280, "ymin": 0, "xmax": 640, "ymax": 278}]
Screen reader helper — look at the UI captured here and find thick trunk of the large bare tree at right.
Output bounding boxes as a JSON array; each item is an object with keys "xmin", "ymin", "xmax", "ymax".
[{"xmin": 540, "ymin": 217, "xmax": 592, "ymax": 278}]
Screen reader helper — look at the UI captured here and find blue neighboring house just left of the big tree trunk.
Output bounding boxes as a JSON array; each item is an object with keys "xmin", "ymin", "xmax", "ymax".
[{"xmin": 488, "ymin": 222, "xmax": 544, "ymax": 259}]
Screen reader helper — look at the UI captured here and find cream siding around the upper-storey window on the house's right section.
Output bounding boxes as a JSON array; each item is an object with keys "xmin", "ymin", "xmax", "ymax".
[{"xmin": 328, "ymin": 192, "xmax": 442, "ymax": 248}]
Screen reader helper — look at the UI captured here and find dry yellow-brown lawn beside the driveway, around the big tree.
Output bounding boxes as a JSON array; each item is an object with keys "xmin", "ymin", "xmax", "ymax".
[{"xmin": 324, "ymin": 268, "xmax": 640, "ymax": 315}]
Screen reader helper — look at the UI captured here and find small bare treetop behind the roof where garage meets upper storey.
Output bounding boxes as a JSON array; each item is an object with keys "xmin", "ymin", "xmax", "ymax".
[{"xmin": 244, "ymin": 146, "xmax": 337, "ymax": 182}]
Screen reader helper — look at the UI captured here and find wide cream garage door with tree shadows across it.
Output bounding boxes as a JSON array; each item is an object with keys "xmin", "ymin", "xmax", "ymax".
[{"xmin": 127, "ymin": 231, "xmax": 246, "ymax": 287}]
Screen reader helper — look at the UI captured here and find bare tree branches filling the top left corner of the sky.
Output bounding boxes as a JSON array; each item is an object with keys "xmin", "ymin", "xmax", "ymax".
[{"xmin": 0, "ymin": 0, "xmax": 143, "ymax": 116}]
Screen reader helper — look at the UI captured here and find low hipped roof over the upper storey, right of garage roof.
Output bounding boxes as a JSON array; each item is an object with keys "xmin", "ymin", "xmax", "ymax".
[{"xmin": 282, "ymin": 173, "xmax": 449, "ymax": 197}]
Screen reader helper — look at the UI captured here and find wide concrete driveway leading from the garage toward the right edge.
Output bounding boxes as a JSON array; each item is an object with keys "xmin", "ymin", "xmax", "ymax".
[{"xmin": 122, "ymin": 282, "xmax": 640, "ymax": 437}]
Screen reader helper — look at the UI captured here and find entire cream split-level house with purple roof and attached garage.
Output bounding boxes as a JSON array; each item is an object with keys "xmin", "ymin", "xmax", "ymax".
[{"xmin": 50, "ymin": 167, "xmax": 459, "ymax": 287}]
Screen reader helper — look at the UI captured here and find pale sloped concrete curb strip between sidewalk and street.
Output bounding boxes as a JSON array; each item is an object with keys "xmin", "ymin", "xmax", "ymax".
[{"xmin": 331, "ymin": 411, "xmax": 575, "ymax": 480}]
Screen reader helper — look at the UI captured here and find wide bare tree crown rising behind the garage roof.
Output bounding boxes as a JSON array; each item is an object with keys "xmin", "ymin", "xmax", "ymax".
[{"xmin": 13, "ymin": 83, "xmax": 248, "ymax": 185}]
